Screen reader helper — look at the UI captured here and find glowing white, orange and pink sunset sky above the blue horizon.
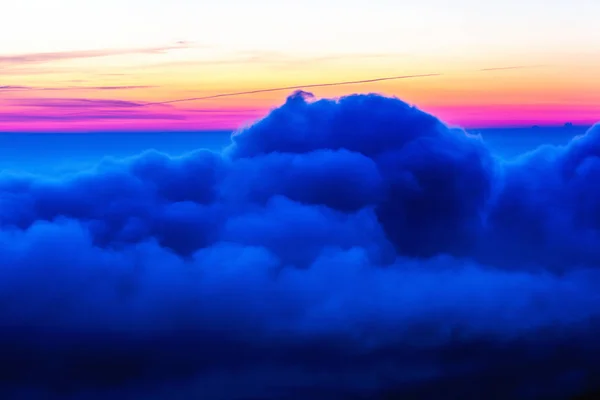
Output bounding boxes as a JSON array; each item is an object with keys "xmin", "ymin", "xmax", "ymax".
[{"xmin": 0, "ymin": 0, "xmax": 600, "ymax": 132}]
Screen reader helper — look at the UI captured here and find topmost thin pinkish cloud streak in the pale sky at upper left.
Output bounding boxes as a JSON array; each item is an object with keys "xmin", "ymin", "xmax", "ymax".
[{"xmin": 0, "ymin": 42, "xmax": 190, "ymax": 67}]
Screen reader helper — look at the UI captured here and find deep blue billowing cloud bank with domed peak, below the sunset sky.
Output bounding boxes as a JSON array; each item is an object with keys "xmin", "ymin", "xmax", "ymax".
[{"xmin": 0, "ymin": 93, "xmax": 600, "ymax": 399}]
